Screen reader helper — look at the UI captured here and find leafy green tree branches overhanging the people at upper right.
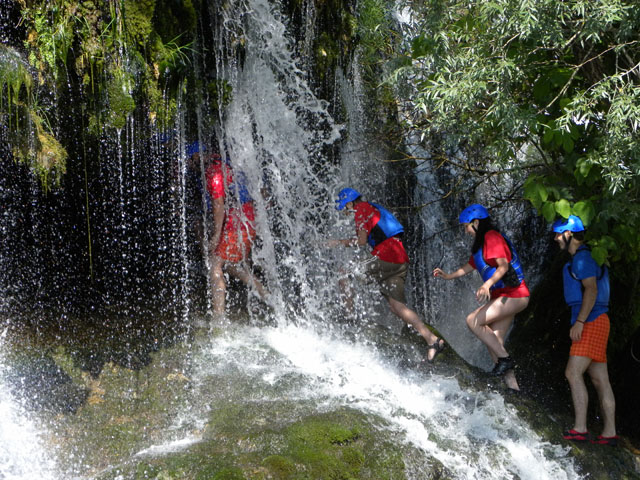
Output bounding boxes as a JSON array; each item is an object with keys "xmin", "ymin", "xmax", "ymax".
[{"xmin": 389, "ymin": 0, "xmax": 640, "ymax": 262}]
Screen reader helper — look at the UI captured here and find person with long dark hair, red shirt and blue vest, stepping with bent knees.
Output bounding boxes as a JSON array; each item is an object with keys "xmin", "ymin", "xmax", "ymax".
[{"xmin": 433, "ymin": 204, "xmax": 529, "ymax": 391}]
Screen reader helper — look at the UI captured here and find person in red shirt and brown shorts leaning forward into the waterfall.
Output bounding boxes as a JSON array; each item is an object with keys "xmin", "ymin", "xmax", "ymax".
[{"xmin": 329, "ymin": 188, "xmax": 445, "ymax": 362}]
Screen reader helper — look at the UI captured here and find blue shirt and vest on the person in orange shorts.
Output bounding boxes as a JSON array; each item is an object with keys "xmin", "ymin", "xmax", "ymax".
[{"xmin": 562, "ymin": 245, "xmax": 609, "ymax": 325}]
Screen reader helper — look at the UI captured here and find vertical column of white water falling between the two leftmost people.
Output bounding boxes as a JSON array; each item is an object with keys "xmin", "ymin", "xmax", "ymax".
[{"xmin": 202, "ymin": 0, "xmax": 339, "ymax": 318}]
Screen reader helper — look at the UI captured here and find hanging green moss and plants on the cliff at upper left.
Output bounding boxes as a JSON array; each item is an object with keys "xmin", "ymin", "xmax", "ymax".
[{"xmin": 10, "ymin": 0, "xmax": 197, "ymax": 188}]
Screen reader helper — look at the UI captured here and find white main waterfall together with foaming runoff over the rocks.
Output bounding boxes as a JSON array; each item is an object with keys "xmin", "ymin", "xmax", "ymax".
[{"xmin": 0, "ymin": 0, "xmax": 592, "ymax": 480}]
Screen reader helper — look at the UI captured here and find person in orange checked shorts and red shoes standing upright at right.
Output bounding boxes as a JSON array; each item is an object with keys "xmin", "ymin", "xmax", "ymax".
[{"xmin": 552, "ymin": 215, "xmax": 618, "ymax": 446}]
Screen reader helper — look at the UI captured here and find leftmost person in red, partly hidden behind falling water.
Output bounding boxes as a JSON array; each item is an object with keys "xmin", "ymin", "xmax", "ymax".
[{"xmin": 205, "ymin": 148, "xmax": 267, "ymax": 315}]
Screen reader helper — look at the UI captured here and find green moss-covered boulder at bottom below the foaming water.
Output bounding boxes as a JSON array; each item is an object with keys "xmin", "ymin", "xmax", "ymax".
[{"xmin": 99, "ymin": 402, "xmax": 444, "ymax": 480}]
